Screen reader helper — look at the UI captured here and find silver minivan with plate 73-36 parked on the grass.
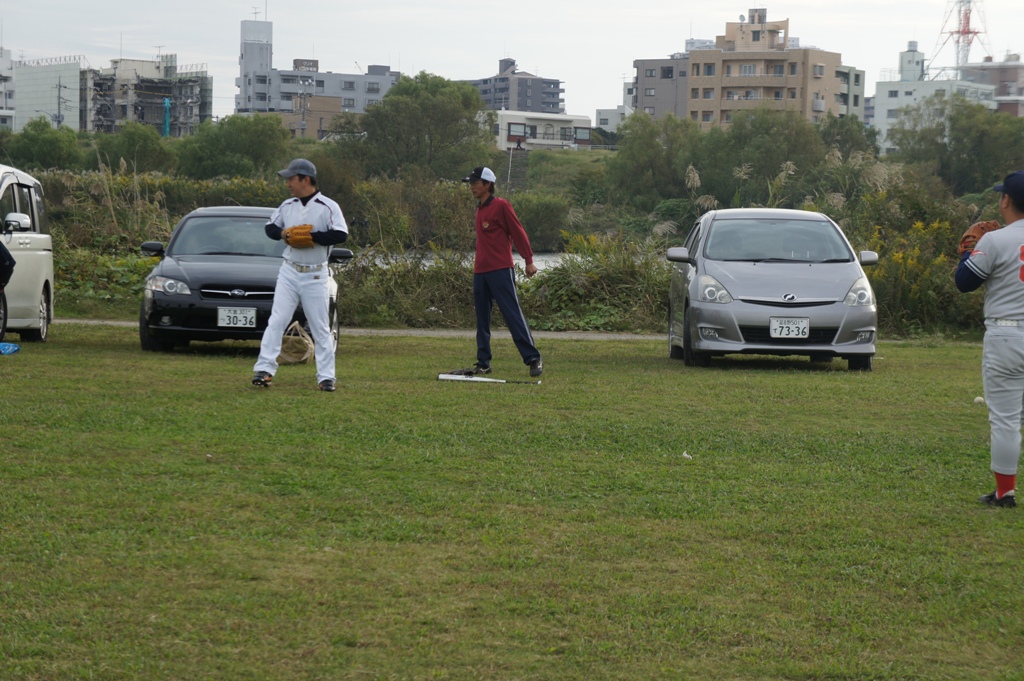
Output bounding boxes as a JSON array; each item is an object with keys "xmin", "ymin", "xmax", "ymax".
[{"xmin": 668, "ymin": 208, "xmax": 879, "ymax": 371}]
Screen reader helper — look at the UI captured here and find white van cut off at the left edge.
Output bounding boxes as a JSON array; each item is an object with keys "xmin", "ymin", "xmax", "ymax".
[{"xmin": 0, "ymin": 165, "xmax": 53, "ymax": 342}]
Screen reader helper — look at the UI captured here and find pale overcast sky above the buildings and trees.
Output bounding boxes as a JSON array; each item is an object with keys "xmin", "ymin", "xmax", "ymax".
[{"xmin": 0, "ymin": 0, "xmax": 1024, "ymax": 120}]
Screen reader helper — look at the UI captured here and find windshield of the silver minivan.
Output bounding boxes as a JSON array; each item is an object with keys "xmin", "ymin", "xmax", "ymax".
[{"xmin": 705, "ymin": 217, "xmax": 853, "ymax": 262}]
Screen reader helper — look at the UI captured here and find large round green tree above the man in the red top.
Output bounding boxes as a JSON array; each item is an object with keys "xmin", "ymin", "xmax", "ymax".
[{"xmin": 333, "ymin": 72, "xmax": 494, "ymax": 177}]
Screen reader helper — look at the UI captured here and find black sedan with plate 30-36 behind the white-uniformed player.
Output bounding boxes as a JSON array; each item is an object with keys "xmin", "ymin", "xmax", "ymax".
[{"xmin": 138, "ymin": 206, "xmax": 352, "ymax": 352}]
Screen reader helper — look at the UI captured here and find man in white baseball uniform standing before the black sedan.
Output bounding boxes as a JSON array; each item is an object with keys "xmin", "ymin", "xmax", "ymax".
[{"xmin": 253, "ymin": 159, "xmax": 348, "ymax": 392}]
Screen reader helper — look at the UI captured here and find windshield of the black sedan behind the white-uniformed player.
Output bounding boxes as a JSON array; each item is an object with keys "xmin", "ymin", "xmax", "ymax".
[{"xmin": 167, "ymin": 215, "xmax": 285, "ymax": 258}]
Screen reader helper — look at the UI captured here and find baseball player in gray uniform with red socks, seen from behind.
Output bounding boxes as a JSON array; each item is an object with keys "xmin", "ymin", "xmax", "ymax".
[{"xmin": 956, "ymin": 171, "xmax": 1024, "ymax": 508}]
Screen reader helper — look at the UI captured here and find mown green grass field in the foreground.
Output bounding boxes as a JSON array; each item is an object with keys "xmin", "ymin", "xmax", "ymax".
[{"xmin": 0, "ymin": 324, "xmax": 1024, "ymax": 680}]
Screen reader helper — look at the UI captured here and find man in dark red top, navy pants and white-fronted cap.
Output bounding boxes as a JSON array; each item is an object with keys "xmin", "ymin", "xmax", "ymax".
[{"xmin": 462, "ymin": 166, "xmax": 544, "ymax": 377}]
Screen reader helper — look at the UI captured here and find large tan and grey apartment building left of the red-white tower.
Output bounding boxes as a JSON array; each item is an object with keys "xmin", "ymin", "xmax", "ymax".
[{"xmin": 634, "ymin": 8, "xmax": 864, "ymax": 130}]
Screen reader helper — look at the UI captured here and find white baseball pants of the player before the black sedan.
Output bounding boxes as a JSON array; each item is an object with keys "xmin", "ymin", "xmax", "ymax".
[{"xmin": 253, "ymin": 262, "xmax": 335, "ymax": 383}]
